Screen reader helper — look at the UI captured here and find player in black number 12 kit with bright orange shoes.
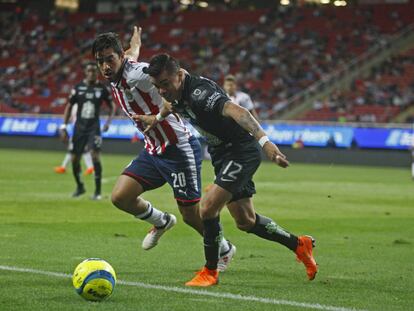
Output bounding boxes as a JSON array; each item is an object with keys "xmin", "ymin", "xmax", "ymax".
[{"xmin": 135, "ymin": 54, "xmax": 318, "ymax": 287}]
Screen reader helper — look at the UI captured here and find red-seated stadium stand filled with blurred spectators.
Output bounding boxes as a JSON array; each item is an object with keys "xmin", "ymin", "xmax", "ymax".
[{"xmin": 0, "ymin": 2, "xmax": 414, "ymax": 122}]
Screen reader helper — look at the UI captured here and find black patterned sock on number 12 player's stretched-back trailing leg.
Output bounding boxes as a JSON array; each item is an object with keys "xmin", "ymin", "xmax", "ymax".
[{"xmin": 249, "ymin": 214, "xmax": 298, "ymax": 251}]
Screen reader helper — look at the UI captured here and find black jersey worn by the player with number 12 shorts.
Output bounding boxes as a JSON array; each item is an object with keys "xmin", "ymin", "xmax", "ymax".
[{"xmin": 172, "ymin": 73, "xmax": 254, "ymax": 146}]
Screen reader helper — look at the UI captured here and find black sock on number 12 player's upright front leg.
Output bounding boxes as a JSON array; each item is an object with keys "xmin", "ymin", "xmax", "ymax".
[{"xmin": 203, "ymin": 217, "xmax": 222, "ymax": 270}]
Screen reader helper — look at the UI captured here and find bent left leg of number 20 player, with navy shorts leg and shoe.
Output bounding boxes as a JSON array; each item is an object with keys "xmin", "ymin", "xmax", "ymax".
[{"xmin": 112, "ymin": 150, "xmax": 177, "ymax": 250}]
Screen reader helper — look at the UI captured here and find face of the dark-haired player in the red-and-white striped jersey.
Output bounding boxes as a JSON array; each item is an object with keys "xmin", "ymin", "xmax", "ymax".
[{"xmin": 95, "ymin": 48, "xmax": 124, "ymax": 82}]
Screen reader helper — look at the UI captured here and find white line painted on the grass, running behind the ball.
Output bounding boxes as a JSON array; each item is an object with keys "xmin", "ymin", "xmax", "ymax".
[{"xmin": 0, "ymin": 265, "xmax": 363, "ymax": 311}]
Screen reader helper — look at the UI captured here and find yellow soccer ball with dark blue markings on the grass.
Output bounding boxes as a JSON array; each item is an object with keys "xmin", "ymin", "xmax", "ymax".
[{"xmin": 72, "ymin": 258, "xmax": 116, "ymax": 301}]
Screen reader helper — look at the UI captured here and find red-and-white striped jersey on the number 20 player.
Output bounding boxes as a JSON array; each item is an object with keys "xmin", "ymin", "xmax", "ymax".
[{"xmin": 111, "ymin": 60, "xmax": 191, "ymax": 154}]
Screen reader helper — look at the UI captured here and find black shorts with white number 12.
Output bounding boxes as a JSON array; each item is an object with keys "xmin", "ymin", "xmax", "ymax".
[{"xmin": 209, "ymin": 140, "xmax": 262, "ymax": 202}]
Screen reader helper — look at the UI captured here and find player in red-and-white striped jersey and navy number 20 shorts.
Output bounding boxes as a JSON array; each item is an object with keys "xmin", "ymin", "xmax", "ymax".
[{"xmin": 92, "ymin": 28, "xmax": 235, "ymax": 270}]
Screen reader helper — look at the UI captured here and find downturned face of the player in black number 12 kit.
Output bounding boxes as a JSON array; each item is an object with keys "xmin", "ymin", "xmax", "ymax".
[{"xmin": 151, "ymin": 70, "xmax": 184, "ymax": 102}]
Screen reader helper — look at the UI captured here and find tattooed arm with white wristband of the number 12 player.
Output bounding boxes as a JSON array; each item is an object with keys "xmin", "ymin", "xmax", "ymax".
[{"xmin": 222, "ymin": 101, "xmax": 289, "ymax": 167}]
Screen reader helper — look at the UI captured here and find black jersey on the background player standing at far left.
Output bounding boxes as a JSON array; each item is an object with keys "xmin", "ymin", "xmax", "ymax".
[{"xmin": 69, "ymin": 81, "xmax": 111, "ymax": 131}]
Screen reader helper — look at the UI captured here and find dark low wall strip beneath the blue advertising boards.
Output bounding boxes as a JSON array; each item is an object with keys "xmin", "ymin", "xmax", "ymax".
[{"xmin": 0, "ymin": 136, "xmax": 411, "ymax": 168}]
